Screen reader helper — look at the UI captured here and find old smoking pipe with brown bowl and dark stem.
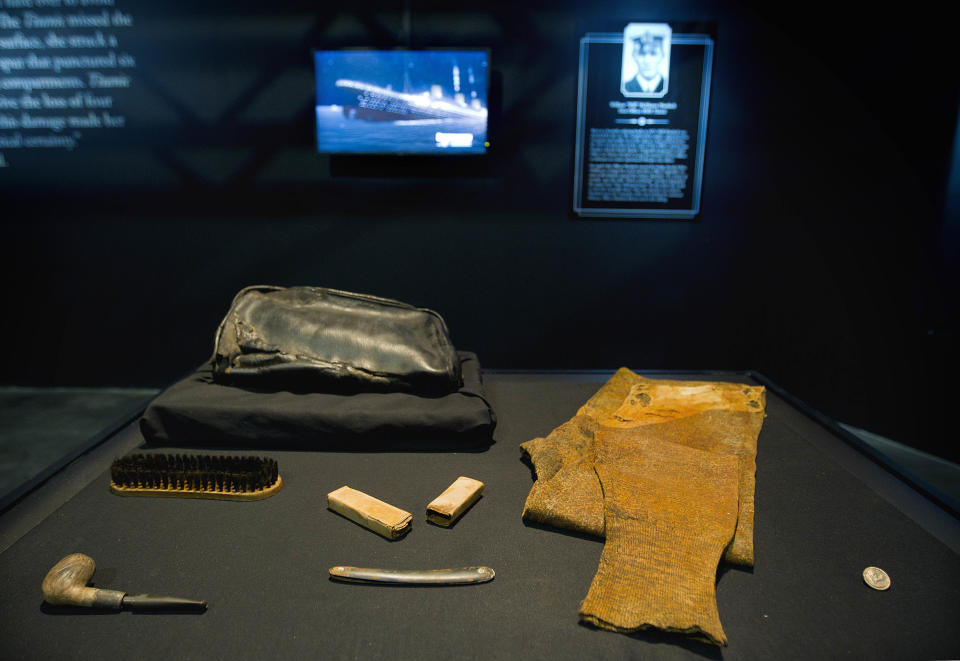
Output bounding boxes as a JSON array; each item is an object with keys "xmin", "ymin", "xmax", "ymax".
[{"xmin": 40, "ymin": 553, "xmax": 207, "ymax": 610}]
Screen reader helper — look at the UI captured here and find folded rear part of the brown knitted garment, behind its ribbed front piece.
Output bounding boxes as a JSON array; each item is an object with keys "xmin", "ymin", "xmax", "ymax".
[{"xmin": 520, "ymin": 368, "xmax": 765, "ymax": 566}]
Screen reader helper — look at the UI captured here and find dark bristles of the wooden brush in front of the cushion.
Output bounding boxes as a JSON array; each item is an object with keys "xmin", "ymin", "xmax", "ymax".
[{"xmin": 110, "ymin": 454, "xmax": 279, "ymax": 493}]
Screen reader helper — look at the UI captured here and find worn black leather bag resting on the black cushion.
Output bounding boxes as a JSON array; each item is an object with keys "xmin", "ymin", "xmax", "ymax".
[{"xmin": 213, "ymin": 286, "xmax": 461, "ymax": 394}]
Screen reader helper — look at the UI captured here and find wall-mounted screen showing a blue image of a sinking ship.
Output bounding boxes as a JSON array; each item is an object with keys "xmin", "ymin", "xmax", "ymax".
[{"xmin": 314, "ymin": 50, "xmax": 487, "ymax": 154}]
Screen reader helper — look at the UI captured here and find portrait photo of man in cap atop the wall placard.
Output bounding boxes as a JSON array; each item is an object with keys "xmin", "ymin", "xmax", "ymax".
[{"xmin": 620, "ymin": 23, "xmax": 671, "ymax": 97}]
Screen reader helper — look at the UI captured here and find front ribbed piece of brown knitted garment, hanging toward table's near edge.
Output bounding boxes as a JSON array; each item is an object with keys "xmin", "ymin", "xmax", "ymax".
[{"xmin": 580, "ymin": 429, "xmax": 738, "ymax": 645}]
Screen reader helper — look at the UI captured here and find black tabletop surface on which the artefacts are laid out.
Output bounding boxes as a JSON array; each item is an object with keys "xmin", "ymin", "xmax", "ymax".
[{"xmin": 0, "ymin": 373, "xmax": 960, "ymax": 660}]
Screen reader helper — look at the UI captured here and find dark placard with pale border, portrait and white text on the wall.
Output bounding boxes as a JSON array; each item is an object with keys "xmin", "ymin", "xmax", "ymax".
[{"xmin": 573, "ymin": 23, "xmax": 713, "ymax": 220}]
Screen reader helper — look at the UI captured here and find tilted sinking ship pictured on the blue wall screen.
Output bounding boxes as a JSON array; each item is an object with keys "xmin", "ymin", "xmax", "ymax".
[{"xmin": 335, "ymin": 78, "xmax": 487, "ymax": 122}]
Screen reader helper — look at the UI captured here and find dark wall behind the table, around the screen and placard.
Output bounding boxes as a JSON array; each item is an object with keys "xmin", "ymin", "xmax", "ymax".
[{"xmin": 0, "ymin": 0, "xmax": 960, "ymax": 460}]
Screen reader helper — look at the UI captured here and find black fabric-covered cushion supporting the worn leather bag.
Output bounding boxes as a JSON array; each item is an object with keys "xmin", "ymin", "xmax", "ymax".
[{"xmin": 140, "ymin": 352, "xmax": 496, "ymax": 450}]
